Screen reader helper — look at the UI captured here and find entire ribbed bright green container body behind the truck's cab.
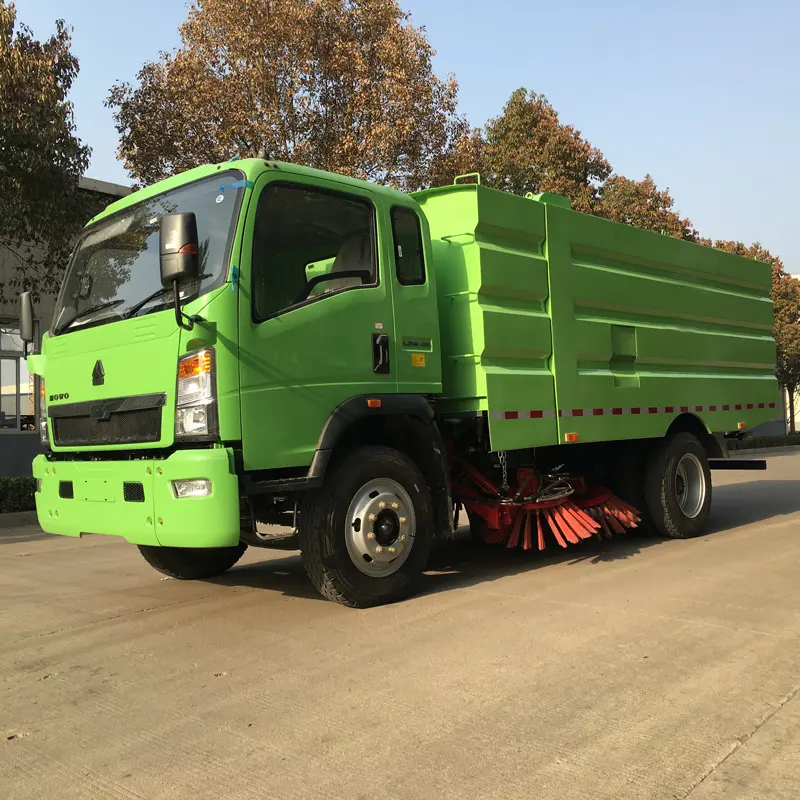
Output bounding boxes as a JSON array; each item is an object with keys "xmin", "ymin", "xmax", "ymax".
[{"xmin": 414, "ymin": 184, "xmax": 778, "ymax": 450}]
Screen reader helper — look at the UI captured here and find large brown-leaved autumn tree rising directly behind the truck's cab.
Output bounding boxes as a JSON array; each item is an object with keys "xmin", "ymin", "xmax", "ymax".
[{"xmin": 108, "ymin": 0, "xmax": 462, "ymax": 189}]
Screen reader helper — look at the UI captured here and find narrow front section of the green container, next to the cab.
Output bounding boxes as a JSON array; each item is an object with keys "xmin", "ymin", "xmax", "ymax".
[{"xmin": 416, "ymin": 187, "xmax": 557, "ymax": 450}]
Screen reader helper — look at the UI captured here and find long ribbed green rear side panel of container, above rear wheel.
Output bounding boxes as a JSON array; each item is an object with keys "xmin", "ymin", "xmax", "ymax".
[{"xmin": 547, "ymin": 206, "xmax": 778, "ymax": 442}]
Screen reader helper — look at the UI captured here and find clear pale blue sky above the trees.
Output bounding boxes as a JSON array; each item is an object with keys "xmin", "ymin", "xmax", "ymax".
[{"xmin": 16, "ymin": 0, "xmax": 800, "ymax": 274}]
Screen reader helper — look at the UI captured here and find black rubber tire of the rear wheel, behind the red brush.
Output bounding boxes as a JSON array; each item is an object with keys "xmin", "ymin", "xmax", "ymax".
[{"xmin": 644, "ymin": 433, "xmax": 711, "ymax": 539}]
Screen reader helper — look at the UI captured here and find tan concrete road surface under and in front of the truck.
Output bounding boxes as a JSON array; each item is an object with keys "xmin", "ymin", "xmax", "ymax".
[{"xmin": 0, "ymin": 455, "xmax": 800, "ymax": 800}]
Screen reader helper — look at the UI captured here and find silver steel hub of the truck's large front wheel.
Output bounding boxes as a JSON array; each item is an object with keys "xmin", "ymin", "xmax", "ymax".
[{"xmin": 345, "ymin": 478, "xmax": 416, "ymax": 577}]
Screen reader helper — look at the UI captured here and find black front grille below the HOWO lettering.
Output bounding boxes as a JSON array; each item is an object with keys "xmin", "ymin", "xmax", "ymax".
[{"xmin": 47, "ymin": 394, "xmax": 166, "ymax": 447}]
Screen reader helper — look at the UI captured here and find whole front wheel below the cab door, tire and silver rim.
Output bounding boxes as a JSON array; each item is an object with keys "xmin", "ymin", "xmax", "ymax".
[{"xmin": 299, "ymin": 447, "xmax": 433, "ymax": 608}]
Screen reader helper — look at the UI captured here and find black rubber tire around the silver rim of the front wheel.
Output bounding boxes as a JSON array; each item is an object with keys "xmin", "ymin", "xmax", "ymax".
[{"xmin": 299, "ymin": 447, "xmax": 434, "ymax": 608}]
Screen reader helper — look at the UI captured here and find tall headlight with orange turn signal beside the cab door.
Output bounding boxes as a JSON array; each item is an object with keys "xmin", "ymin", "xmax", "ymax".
[{"xmin": 175, "ymin": 348, "xmax": 219, "ymax": 439}]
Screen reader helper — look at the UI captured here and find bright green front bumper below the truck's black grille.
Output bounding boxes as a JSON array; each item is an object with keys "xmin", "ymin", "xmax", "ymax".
[{"xmin": 33, "ymin": 447, "xmax": 240, "ymax": 547}]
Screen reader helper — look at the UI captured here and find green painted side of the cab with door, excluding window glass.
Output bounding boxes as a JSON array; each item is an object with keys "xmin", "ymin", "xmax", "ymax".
[{"xmin": 239, "ymin": 168, "xmax": 441, "ymax": 470}]
